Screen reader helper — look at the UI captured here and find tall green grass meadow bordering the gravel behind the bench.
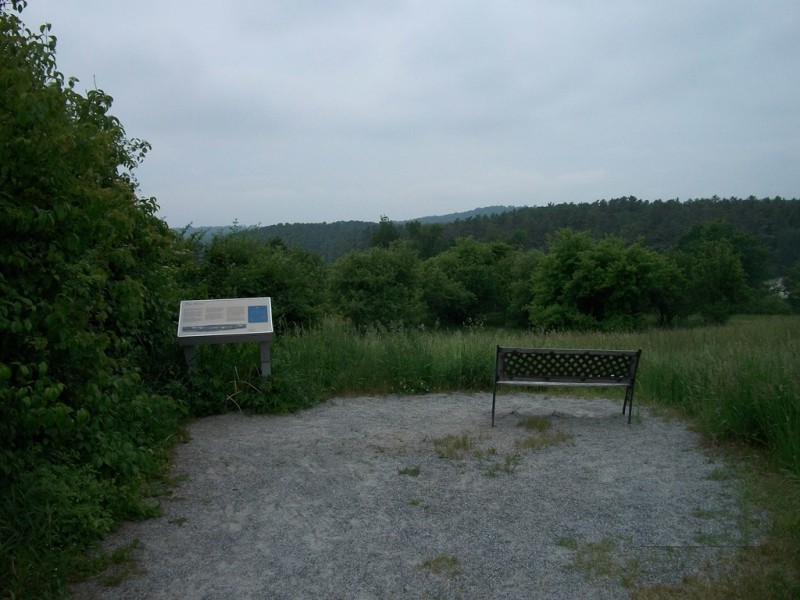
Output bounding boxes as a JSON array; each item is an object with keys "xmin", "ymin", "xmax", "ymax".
[{"xmin": 214, "ymin": 316, "xmax": 800, "ymax": 478}]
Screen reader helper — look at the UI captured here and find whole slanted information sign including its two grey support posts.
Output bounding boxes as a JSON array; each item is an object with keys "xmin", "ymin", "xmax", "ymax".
[{"xmin": 178, "ymin": 298, "xmax": 274, "ymax": 377}]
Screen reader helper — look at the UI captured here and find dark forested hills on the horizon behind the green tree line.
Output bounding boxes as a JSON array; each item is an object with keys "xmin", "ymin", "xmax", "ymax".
[{"xmin": 244, "ymin": 196, "xmax": 800, "ymax": 272}]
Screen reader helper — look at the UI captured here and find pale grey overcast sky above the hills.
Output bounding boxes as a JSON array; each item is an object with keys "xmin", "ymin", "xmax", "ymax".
[{"xmin": 17, "ymin": 0, "xmax": 800, "ymax": 227}]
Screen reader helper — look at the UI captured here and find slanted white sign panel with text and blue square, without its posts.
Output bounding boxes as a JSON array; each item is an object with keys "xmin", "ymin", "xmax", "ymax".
[{"xmin": 178, "ymin": 298, "xmax": 273, "ymax": 343}]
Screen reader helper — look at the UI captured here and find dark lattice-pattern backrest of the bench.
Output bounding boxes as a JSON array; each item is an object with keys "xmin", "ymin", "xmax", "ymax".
[{"xmin": 500, "ymin": 350, "xmax": 635, "ymax": 381}]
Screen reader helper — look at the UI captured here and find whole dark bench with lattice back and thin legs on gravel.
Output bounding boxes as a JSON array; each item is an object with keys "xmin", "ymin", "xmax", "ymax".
[{"xmin": 492, "ymin": 346, "xmax": 642, "ymax": 427}]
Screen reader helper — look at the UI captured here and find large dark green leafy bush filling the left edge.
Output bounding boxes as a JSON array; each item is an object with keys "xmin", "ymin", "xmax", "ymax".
[{"xmin": 0, "ymin": 2, "xmax": 182, "ymax": 597}]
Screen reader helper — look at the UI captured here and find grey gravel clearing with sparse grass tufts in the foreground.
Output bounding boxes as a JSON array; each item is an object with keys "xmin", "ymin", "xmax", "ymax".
[{"xmin": 74, "ymin": 393, "xmax": 755, "ymax": 600}]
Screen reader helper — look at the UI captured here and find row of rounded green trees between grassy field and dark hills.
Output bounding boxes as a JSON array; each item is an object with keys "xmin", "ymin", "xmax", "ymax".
[{"xmin": 202, "ymin": 219, "xmax": 797, "ymax": 330}]
